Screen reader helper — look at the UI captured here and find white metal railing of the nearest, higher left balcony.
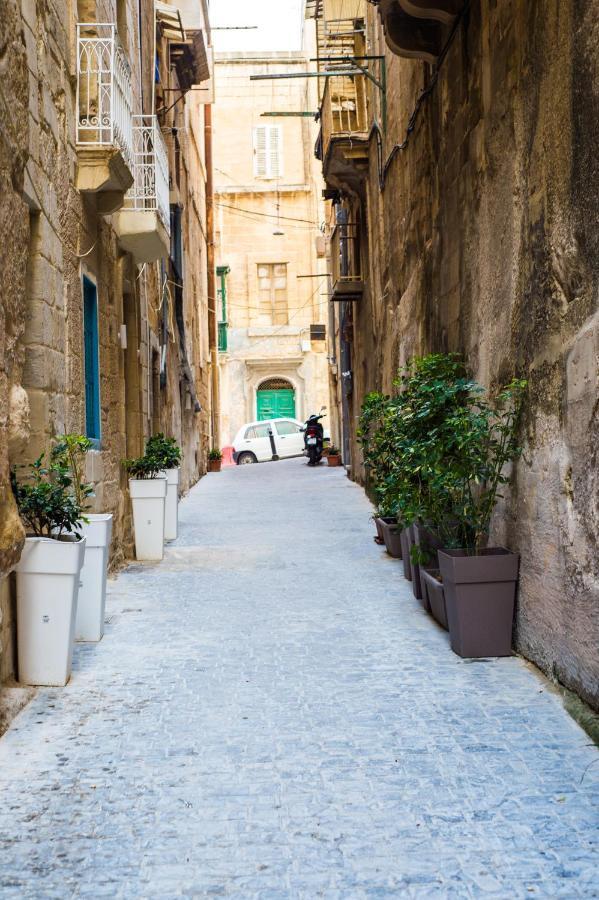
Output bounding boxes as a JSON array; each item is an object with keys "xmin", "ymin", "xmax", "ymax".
[{"xmin": 77, "ymin": 22, "xmax": 133, "ymax": 168}]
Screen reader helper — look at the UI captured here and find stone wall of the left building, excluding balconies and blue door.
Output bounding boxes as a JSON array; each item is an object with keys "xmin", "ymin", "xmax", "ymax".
[{"xmin": 0, "ymin": 0, "xmax": 211, "ymax": 678}]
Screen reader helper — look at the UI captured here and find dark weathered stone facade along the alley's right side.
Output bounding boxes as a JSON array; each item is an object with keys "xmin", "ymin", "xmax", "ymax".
[{"xmin": 316, "ymin": 0, "xmax": 599, "ymax": 706}]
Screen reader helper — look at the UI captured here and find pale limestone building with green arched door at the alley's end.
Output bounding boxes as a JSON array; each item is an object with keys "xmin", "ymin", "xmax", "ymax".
[{"xmin": 214, "ymin": 38, "xmax": 328, "ymax": 444}]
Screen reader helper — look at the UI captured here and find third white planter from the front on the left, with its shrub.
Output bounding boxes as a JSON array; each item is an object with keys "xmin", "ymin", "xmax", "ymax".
[{"xmin": 123, "ymin": 454, "xmax": 167, "ymax": 560}]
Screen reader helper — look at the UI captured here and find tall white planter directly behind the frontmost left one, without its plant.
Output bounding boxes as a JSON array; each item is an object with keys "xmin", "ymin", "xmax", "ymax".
[{"xmin": 75, "ymin": 513, "xmax": 112, "ymax": 641}]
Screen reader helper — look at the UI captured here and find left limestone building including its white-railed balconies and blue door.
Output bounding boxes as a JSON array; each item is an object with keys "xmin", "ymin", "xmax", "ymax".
[{"xmin": 0, "ymin": 0, "xmax": 218, "ymax": 677}]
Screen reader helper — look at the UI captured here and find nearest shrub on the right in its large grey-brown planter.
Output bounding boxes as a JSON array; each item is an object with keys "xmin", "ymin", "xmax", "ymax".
[{"xmin": 438, "ymin": 380, "xmax": 526, "ymax": 657}]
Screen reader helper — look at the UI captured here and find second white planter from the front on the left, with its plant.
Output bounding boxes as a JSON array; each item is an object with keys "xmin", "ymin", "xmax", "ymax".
[{"xmin": 52, "ymin": 434, "xmax": 112, "ymax": 641}]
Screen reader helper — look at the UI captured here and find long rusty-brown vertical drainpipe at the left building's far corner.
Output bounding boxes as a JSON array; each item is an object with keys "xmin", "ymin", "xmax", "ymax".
[{"xmin": 204, "ymin": 103, "xmax": 220, "ymax": 447}]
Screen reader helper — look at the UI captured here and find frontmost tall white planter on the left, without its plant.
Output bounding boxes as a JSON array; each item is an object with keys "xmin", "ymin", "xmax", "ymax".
[{"xmin": 15, "ymin": 537, "xmax": 85, "ymax": 686}]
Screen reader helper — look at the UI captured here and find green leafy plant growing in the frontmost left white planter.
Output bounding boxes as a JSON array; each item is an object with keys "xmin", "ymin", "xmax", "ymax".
[{"xmin": 11, "ymin": 453, "xmax": 84, "ymax": 540}]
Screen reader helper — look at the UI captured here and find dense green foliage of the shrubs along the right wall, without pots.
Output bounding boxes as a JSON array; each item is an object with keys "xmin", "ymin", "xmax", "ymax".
[{"xmin": 359, "ymin": 354, "xmax": 526, "ymax": 562}]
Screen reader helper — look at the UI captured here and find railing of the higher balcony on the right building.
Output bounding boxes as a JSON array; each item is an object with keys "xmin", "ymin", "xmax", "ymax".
[{"xmin": 321, "ymin": 75, "xmax": 368, "ymax": 153}]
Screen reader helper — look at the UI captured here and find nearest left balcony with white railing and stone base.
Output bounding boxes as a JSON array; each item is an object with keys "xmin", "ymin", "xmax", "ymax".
[{"xmin": 76, "ymin": 22, "xmax": 133, "ymax": 214}]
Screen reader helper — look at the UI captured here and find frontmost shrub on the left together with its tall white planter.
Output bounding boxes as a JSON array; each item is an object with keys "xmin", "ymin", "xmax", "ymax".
[{"xmin": 11, "ymin": 454, "xmax": 85, "ymax": 686}]
